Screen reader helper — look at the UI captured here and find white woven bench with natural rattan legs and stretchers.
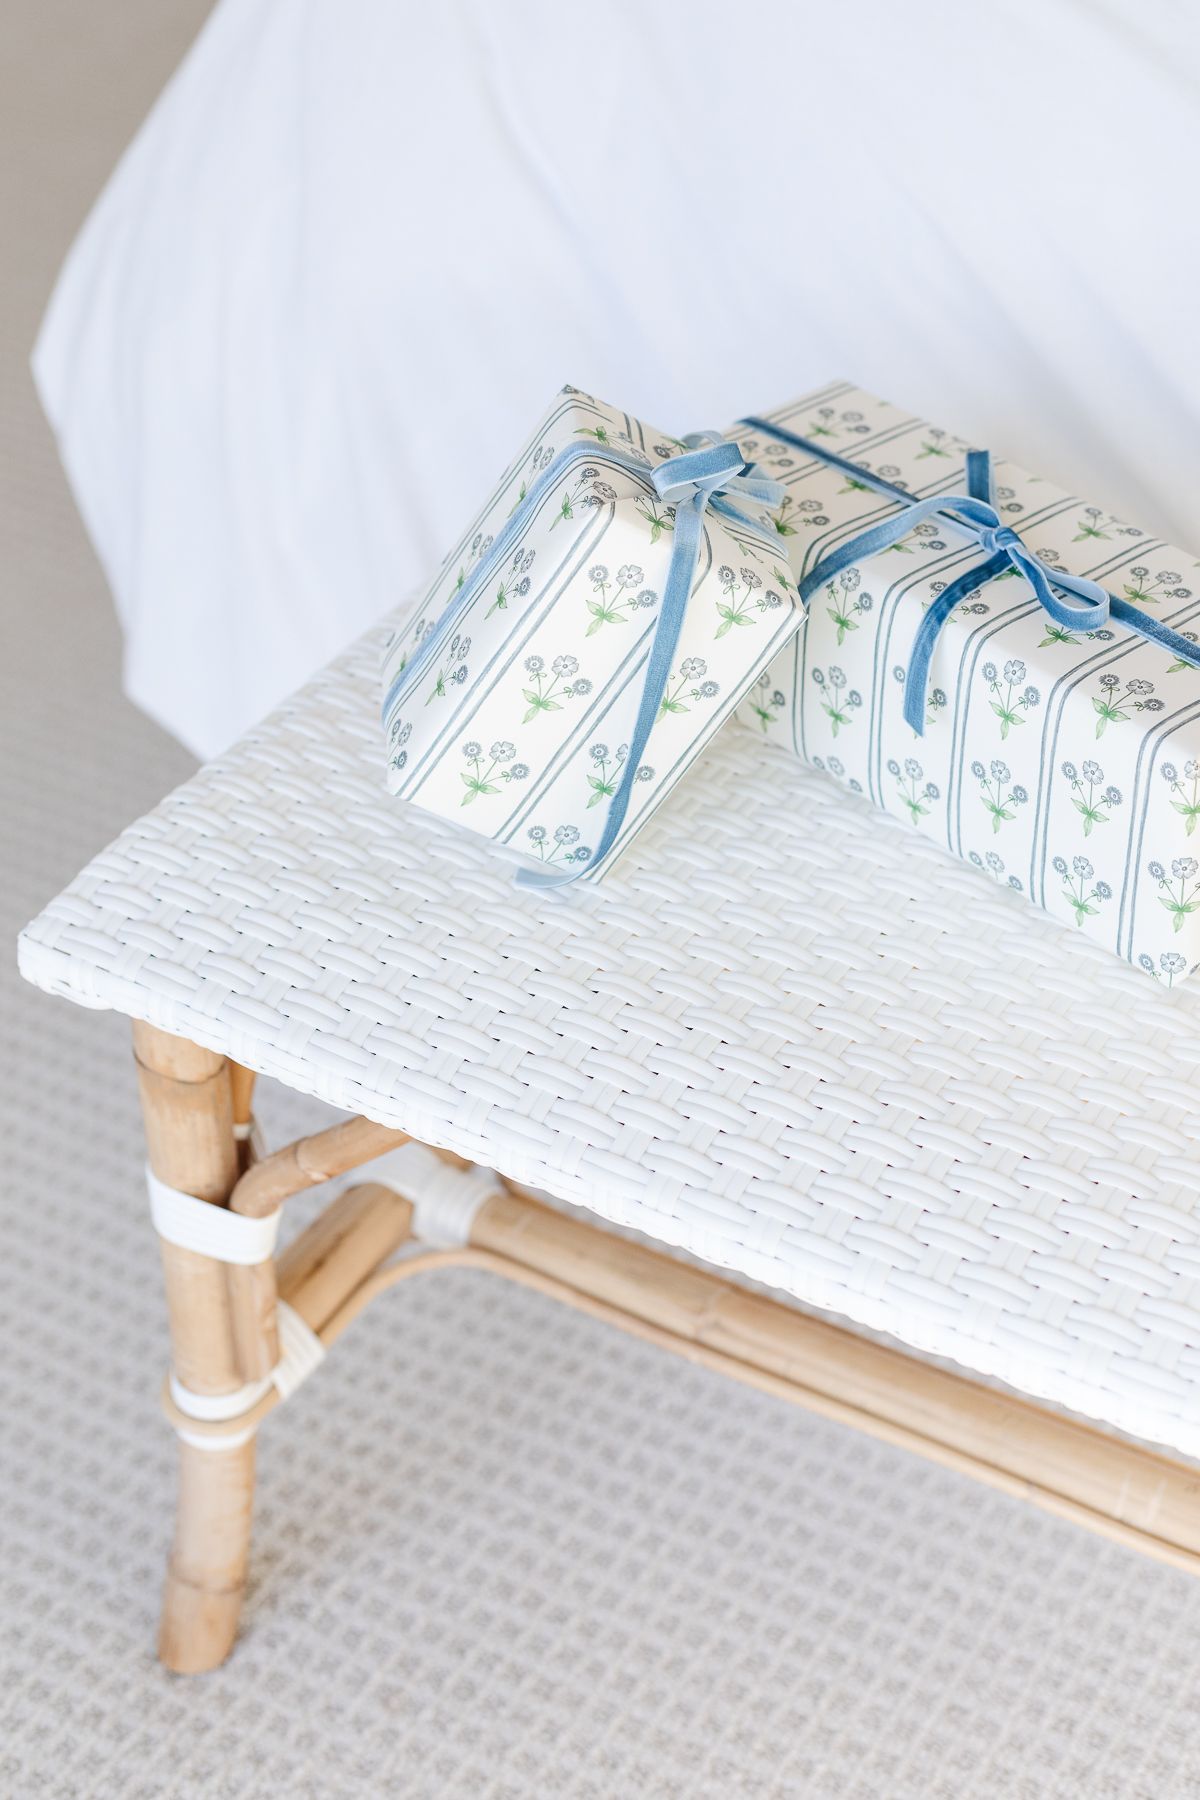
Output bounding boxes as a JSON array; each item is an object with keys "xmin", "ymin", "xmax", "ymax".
[{"xmin": 20, "ymin": 619, "xmax": 1200, "ymax": 1669}]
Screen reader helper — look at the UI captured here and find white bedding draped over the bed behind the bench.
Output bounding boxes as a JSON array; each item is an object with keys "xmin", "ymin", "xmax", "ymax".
[{"xmin": 34, "ymin": 0, "xmax": 1200, "ymax": 754}]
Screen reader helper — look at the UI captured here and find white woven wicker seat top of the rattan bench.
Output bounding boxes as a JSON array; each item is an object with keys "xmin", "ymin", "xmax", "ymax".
[{"xmin": 20, "ymin": 622, "xmax": 1200, "ymax": 1454}]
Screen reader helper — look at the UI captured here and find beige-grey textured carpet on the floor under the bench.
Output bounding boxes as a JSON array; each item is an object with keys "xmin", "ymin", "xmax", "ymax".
[{"xmin": 0, "ymin": 0, "xmax": 1200, "ymax": 1800}]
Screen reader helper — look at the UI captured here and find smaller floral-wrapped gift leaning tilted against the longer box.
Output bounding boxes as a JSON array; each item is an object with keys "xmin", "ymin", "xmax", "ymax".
[{"xmin": 383, "ymin": 389, "xmax": 801, "ymax": 886}]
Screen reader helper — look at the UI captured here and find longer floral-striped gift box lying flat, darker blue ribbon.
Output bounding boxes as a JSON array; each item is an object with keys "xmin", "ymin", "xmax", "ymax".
[{"xmin": 738, "ymin": 383, "xmax": 1200, "ymax": 986}]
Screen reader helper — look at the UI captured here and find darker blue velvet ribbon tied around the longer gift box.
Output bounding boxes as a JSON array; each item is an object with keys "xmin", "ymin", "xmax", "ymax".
[{"xmin": 741, "ymin": 418, "xmax": 1200, "ymax": 736}]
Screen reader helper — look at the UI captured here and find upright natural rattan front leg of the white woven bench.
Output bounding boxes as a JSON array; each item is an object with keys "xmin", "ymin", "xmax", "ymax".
[{"xmin": 133, "ymin": 1024, "xmax": 254, "ymax": 1674}]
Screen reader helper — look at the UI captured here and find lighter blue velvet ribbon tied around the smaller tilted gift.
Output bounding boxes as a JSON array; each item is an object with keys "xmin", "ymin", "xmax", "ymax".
[{"xmin": 383, "ymin": 432, "xmax": 784, "ymax": 887}]
